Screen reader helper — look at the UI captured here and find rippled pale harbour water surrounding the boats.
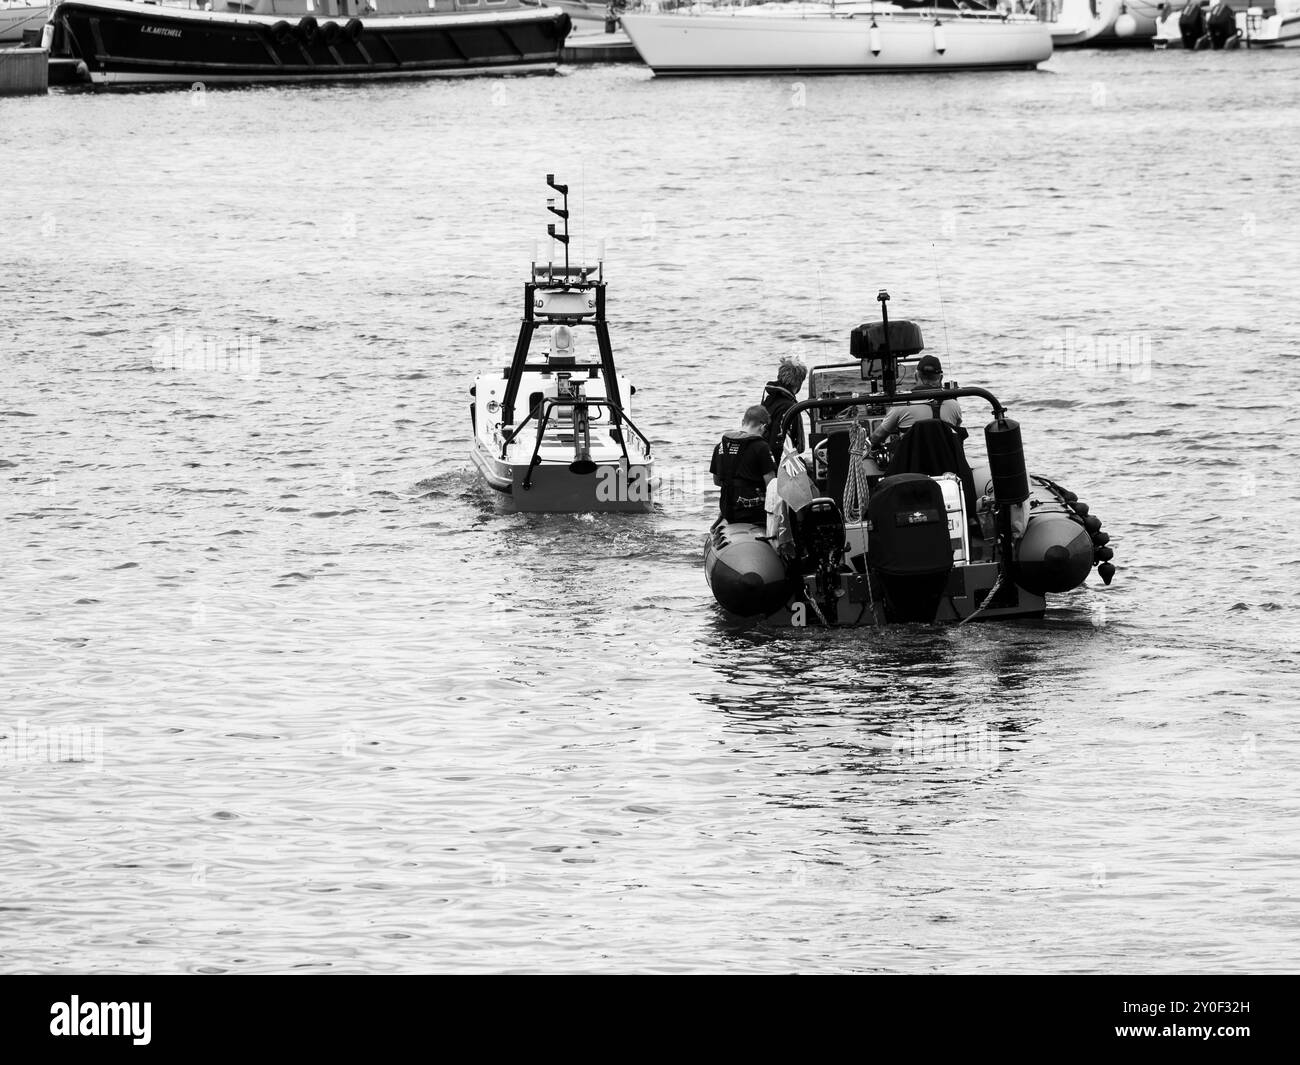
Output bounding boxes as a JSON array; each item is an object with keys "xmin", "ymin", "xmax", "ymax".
[{"xmin": 0, "ymin": 51, "xmax": 1300, "ymax": 973}]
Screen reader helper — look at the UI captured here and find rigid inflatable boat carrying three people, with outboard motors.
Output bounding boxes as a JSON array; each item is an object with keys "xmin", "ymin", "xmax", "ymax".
[{"xmin": 705, "ymin": 293, "xmax": 1115, "ymax": 625}]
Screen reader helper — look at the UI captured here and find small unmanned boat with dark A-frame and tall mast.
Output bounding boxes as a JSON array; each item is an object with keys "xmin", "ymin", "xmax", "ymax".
[{"xmin": 469, "ymin": 174, "xmax": 653, "ymax": 514}]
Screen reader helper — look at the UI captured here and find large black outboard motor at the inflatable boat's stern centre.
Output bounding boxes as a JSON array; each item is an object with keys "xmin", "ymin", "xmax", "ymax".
[{"xmin": 867, "ymin": 473, "xmax": 953, "ymax": 622}]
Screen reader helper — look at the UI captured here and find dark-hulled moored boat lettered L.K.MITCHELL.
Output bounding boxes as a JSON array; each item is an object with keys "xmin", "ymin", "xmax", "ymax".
[{"xmin": 49, "ymin": 0, "xmax": 571, "ymax": 86}]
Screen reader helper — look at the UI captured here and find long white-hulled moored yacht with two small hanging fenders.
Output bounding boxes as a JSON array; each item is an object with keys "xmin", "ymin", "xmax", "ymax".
[{"xmin": 623, "ymin": 0, "xmax": 1052, "ymax": 74}]
